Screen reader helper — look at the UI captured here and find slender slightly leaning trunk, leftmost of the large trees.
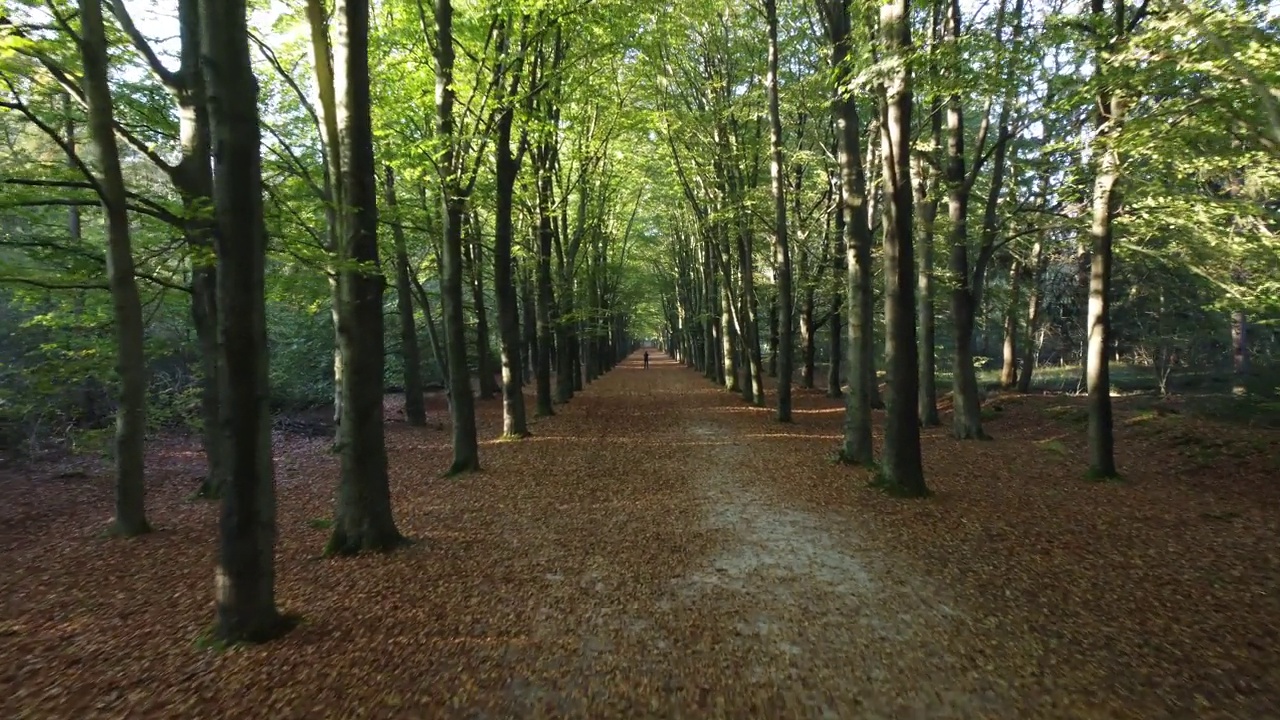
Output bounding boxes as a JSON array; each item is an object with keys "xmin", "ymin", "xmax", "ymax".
[{"xmin": 79, "ymin": 0, "xmax": 151, "ymax": 537}]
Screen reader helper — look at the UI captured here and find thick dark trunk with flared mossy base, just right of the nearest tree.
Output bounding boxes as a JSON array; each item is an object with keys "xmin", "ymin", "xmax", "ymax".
[{"xmin": 325, "ymin": 0, "xmax": 404, "ymax": 555}]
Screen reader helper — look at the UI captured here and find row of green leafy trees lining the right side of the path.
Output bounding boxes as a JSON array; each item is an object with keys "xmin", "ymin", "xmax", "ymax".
[{"xmin": 653, "ymin": 0, "xmax": 1280, "ymax": 495}]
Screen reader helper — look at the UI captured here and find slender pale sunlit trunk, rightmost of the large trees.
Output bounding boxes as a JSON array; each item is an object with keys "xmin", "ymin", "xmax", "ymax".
[{"xmin": 1085, "ymin": 0, "xmax": 1128, "ymax": 479}]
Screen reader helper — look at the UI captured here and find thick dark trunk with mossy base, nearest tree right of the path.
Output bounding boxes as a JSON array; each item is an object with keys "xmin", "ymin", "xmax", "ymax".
[{"xmin": 881, "ymin": 0, "xmax": 928, "ymax": 497}]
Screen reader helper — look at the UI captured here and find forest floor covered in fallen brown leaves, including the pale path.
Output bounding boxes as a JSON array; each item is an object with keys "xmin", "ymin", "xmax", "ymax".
[{"xmin": 0, "ymin": 356, "xmax": 1280, "ymax": 719}]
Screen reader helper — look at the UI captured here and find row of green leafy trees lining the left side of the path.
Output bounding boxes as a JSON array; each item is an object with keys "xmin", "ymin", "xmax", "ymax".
[{"xmin": 0, "ymin": 0, "xmax": 646, "ymax": 641}]
